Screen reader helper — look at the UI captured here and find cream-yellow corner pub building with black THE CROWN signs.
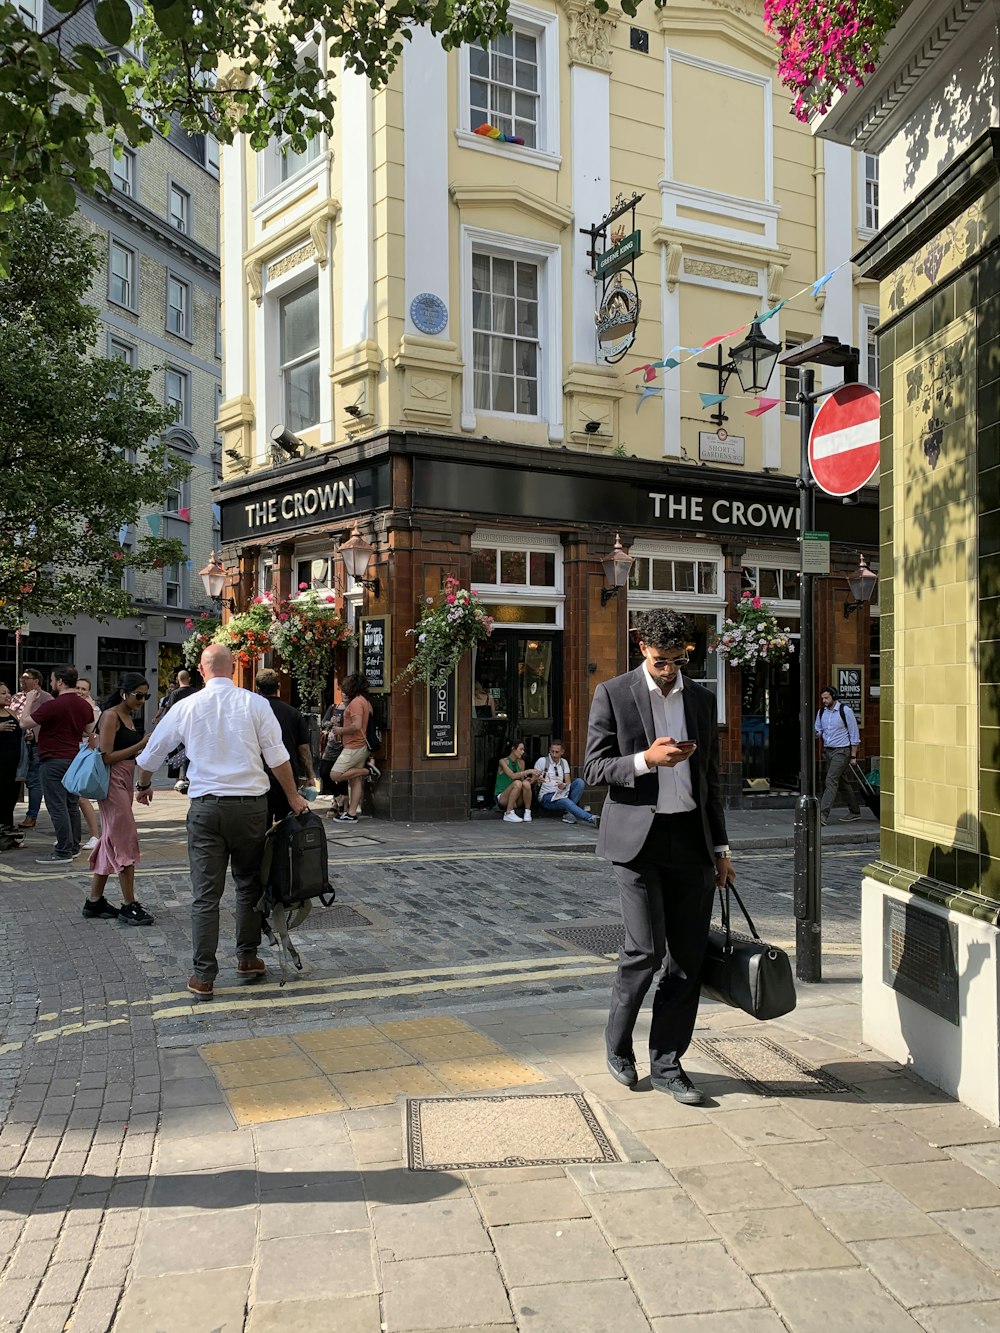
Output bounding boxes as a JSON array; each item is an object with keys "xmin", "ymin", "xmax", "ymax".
[{"xmin": 220, "ymin": 0, "xmax": 877, "ymax": 804}]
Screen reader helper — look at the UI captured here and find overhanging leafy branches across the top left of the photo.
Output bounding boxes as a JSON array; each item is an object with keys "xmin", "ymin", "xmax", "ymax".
[{"xmin": 0, "ymin": 0, "xmax": 650, "ymax": 264}]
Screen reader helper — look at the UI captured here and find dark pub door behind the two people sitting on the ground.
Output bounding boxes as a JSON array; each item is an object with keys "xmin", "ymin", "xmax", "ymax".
[{"xmin": 472, "ymin": 629, "xmax": 563, "ymax": 809}]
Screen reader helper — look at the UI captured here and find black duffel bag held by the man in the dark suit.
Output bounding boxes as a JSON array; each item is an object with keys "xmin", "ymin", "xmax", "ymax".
[{"xmin": 701, "ymin": 880, "xmax": 796, "ymax": 1018}]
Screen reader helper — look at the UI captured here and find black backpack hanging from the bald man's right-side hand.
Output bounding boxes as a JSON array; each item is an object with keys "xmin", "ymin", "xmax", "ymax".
[{"xmin": 257, "ymin": 810, "xmax": 336, "ymax": 985}]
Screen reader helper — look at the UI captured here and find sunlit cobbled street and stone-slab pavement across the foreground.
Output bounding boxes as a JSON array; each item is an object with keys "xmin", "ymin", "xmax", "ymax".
[{"xmin": 17, "ymin": 793, "xmax": 1000, "ymax": 1333}]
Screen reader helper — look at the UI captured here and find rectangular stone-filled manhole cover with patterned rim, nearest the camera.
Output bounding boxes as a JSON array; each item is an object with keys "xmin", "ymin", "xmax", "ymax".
[{"xmin": 407, "ymin": 1093, "xmax": 621, "ymax": 1170}]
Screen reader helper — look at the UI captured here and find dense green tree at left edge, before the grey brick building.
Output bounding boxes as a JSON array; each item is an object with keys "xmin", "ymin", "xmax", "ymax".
[{"xmin": 0, "ymin": 207, "xmax": 188, "ymax": 629}]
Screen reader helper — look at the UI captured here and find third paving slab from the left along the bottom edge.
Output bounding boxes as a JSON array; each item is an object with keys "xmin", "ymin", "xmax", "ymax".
[{"xmin": 381, "ymin": 1254, "xmax": 512, "ymax": 1333}]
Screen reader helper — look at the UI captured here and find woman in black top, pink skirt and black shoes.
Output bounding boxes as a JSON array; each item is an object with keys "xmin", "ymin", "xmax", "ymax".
[{"xmin": 83, "ymin": 672, "xmax": 153, "ymax": 925}]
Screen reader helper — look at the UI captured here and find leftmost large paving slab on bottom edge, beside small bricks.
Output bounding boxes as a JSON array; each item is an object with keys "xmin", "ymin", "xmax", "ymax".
[{"xmin": 115, "ymin": 1268, "xmax": 251, "ymax": 1333}]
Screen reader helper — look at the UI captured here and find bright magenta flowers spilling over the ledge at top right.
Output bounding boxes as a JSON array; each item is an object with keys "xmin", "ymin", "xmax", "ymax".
[{"xmin": 764, "ymin": 0, "xmax": 900, "ymax": 121}]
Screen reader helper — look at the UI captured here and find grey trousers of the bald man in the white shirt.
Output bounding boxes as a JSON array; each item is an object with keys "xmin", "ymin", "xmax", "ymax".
[{"xmin": 188, "ymin": 796, "xmax": 268, "ymax": 981}]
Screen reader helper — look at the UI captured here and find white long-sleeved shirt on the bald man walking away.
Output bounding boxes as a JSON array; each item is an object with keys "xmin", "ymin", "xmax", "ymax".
[{"xmin": 136, "ymin": 676, "xmax": 289, "ymax": 797}]
